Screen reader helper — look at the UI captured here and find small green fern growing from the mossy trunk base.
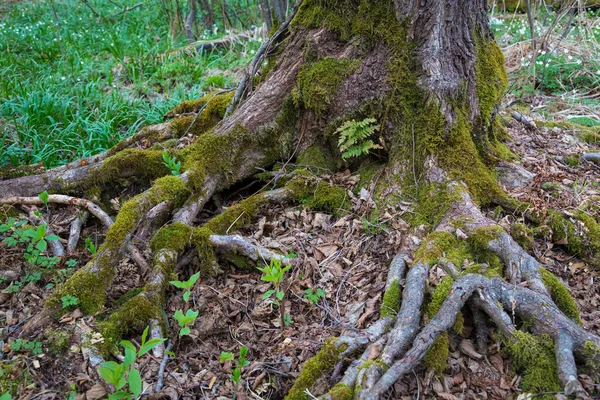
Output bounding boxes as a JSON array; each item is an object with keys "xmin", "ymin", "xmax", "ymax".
[{"xmin": 335, "ymin": 118, "xmax": 381, "ymax": 159}]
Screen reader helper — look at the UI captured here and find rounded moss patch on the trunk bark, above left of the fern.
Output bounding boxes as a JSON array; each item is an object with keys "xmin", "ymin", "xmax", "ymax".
[{"xmin": 292, "ymin": 57, "xmax": 358, "ymax": 115}]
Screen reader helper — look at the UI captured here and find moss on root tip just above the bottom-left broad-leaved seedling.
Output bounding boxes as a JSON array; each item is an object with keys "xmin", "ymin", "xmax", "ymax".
[{"xmin": 98, "ymin": 295, "xmax": 161, "ymax": 356}]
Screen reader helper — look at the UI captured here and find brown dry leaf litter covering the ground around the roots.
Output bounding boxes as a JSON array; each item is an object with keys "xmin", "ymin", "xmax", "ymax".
[{"xmin": 0, "ymin": 104, "xmax": 600, "ymax": 400}]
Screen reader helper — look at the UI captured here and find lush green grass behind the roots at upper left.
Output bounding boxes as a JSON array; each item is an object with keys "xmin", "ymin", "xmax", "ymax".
[{"xmin": 0, "ymin": 0, "xmax": 260, "ymax": 167}]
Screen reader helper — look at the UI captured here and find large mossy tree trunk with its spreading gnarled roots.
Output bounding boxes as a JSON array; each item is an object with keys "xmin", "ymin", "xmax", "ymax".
[{"xmin": 0, "ymin": 0, "xmax": 600, "ymax": 399}]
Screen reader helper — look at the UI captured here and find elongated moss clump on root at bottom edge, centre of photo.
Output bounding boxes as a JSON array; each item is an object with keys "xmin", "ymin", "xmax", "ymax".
[{"xmin": 285, "ymin": 338, "xmax": 347, "ymax": 400}]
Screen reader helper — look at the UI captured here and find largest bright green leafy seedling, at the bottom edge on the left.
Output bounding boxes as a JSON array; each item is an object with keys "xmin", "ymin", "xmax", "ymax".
[{"xmin": 98, "ymin": 327, "xmax": 167, "ymax": 400}]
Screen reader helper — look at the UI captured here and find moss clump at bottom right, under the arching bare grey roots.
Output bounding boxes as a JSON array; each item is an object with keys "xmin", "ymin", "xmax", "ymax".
[{"xmin": 506, "ymin": 331, "xmax": 562, "ymax": 399}]
